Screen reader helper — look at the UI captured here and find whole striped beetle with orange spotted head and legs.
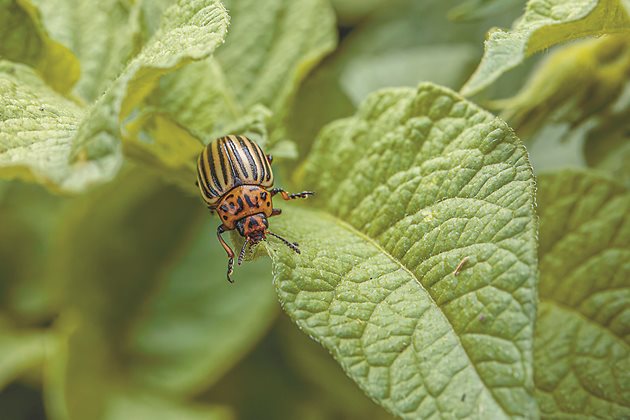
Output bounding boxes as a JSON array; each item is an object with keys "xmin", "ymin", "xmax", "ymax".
[{"xmin": 196, "ymin": 135, "xmax": 314, "ymax": 283}]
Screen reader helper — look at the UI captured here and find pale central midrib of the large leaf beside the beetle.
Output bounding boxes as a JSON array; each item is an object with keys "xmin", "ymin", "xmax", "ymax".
[{"xmin": 284, "ymin": 209, "xmax": 521, "ymax": 416}]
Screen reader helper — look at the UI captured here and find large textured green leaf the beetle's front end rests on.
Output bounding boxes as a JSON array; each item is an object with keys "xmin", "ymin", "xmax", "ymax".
[{"xmin": 269, "ymin": 84, "xmax": 537, "ymax": 418}]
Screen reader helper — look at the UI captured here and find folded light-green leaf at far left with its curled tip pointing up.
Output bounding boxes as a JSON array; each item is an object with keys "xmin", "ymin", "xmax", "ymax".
[{"xmin": 0, "ymin": 0, "xmax": 228, "ymax": 192}]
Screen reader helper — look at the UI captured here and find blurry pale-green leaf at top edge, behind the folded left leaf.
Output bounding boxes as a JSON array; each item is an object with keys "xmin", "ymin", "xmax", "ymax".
[{"xmin": 32, "ymin": 0, "xmax": 146, "ymax": 103}]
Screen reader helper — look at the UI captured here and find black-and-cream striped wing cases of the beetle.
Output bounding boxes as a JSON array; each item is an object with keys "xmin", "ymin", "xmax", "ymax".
[{"xmin": 197, "ymin": 135, "xmax": 273, "ymax": 208}]
